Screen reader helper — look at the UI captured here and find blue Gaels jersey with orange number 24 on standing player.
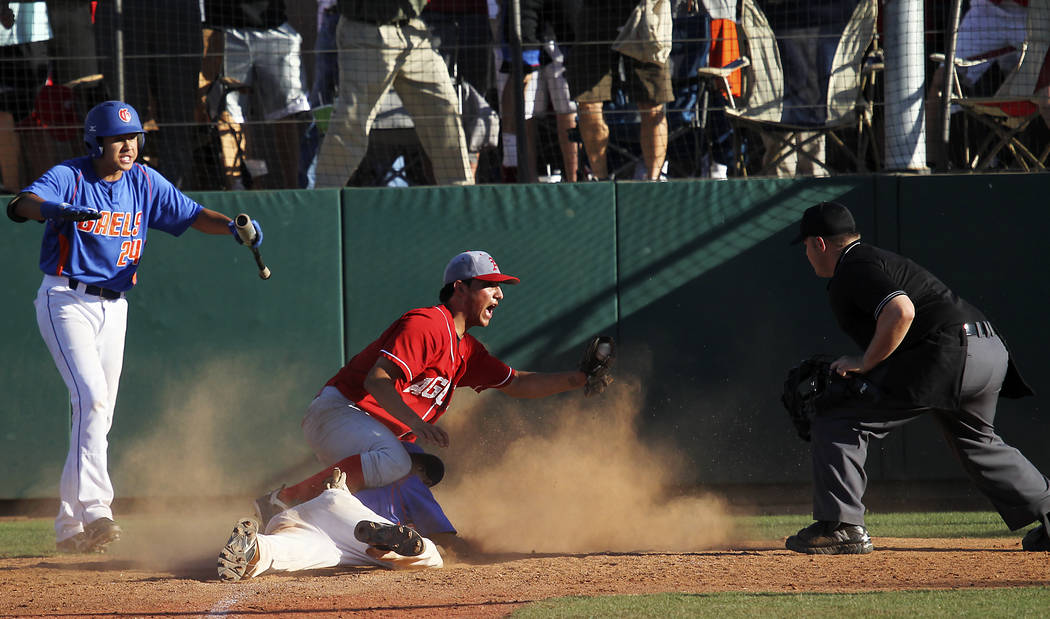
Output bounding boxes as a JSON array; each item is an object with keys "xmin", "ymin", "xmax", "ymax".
[{"xmin": 23, "ymin": 156, "xmax": 203, "ymax": 292}]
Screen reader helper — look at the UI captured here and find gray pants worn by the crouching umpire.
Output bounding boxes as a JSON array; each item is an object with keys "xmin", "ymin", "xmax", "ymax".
[{"xmin": 812, "ymin": 336, "xmax": 1050, "ymax": 530}]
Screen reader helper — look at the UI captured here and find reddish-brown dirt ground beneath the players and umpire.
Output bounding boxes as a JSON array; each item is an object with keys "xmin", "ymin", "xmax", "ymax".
[{"xmin": 0, "ymin": 538, "xmax": 1050, "ymax": 617}]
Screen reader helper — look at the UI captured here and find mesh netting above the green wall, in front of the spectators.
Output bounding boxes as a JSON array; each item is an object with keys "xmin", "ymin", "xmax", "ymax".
[{"xmin": 0, "ymin": 0, "xmax": 1050, "ymax": 193}]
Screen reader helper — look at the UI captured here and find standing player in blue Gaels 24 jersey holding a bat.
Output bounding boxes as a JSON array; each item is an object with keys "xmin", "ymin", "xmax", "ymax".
[{"xmin": 7, "ymin": 101, "xmax": 263, "ymax": 552}]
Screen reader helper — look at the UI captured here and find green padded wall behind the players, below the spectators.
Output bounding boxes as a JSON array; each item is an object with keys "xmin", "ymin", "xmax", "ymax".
[{"xmin": 0, "ymin": 174, "xmax": 1050, "ymax": 498}]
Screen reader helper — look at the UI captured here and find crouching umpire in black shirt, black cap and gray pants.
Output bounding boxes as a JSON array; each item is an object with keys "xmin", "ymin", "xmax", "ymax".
[{"xmin": 786, "ymin": 202, "xmax": 1050, "ymax": 554}]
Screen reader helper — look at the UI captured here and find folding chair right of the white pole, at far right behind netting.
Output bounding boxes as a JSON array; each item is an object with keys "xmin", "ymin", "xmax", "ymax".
[{"xmin": 931, "ymin": 0, "xmax": 1050, "ymax": 172}]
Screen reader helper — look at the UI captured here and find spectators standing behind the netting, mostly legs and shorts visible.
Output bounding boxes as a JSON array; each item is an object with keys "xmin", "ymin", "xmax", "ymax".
[{"xmin": 0, "ymin": 0, "xmax": 1045, "ymax": 193}]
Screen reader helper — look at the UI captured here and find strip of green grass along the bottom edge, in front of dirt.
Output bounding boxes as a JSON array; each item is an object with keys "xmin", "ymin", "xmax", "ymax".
[{"xmin": 511, "ymin": 586, "xmax": 1050, "ymax": 619}]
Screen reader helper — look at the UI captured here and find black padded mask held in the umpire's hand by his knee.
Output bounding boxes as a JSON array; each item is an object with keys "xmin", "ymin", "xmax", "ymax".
[{"xmin": 780, "ymin": 355, "xmax": 881, "ymax": 441}]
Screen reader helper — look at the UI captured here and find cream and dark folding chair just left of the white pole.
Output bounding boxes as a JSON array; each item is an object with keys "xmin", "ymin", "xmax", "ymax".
[{"xmin": 714, "ymin": 0, "xmax": 881, "ymax": 175}]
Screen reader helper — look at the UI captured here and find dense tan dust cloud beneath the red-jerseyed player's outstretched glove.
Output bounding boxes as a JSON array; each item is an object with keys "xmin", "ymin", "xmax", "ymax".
[{"xmin": 435, "ymin": 379, "xmax": 732, "ymax": 553}]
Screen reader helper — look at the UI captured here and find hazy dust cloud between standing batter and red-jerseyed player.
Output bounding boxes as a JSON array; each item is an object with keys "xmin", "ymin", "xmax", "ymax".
[{"xmin": 109, "ymin": 358, "xmax": 317, "ymax": 573}]
